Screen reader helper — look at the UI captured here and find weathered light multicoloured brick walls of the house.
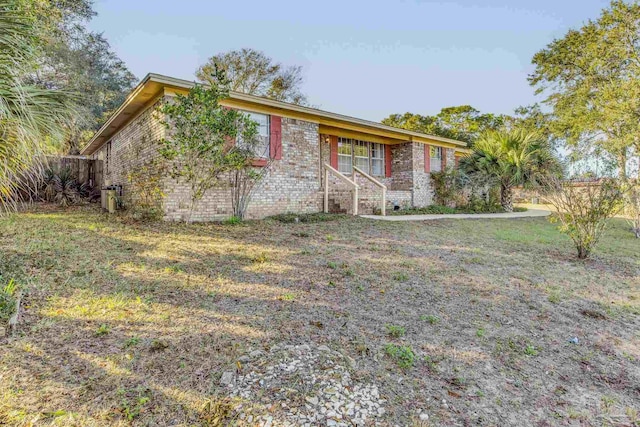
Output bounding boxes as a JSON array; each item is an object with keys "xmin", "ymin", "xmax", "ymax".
[{"xmin": 92, "ymin": 98, "xmax": 455, "ymax": 221}]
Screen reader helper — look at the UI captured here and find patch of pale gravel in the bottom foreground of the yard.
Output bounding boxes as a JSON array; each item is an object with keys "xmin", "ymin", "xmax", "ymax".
[{"xmin": 221, "ymin": 344, "xmax": 386, "ymax": 427}]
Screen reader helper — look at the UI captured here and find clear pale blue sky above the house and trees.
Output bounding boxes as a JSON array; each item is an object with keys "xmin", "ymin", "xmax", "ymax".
[{"xmin": 90, "ymin": 0, "xmax": 609, "ymax": 121}]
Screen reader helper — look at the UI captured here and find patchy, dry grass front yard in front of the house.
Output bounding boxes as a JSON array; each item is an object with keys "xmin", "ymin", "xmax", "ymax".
[{"xmin": 0, "ymin": 207, "xmax": 640, "ymax": 426}]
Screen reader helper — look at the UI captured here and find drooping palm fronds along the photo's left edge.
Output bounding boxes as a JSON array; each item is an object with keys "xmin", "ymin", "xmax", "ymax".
[{"xmin": 0, "ymin": 0, "xmax": 74, "ymax": 213}]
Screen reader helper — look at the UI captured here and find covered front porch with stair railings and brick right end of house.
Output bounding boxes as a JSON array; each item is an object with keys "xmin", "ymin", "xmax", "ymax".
[{"xmin": 320, "ymin": 130, "xmax": 464, "ymax": 216}]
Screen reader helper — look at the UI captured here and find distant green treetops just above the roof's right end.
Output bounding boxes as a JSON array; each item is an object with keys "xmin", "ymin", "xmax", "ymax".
[{"xmin": 382, "ymin": 105, "xmax": 505, "ymax": 144}]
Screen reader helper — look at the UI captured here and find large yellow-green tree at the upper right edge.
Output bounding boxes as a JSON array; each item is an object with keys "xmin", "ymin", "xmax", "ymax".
[{"xmin": 529, "ymin": 0, "xmax": 640, "ymax": 180}]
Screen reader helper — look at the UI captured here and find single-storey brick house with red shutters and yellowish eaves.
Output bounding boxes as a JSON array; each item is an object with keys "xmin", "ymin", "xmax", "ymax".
[{"xmin": 81, "ymin": 74, "xmax": 468, "ymax": 221}]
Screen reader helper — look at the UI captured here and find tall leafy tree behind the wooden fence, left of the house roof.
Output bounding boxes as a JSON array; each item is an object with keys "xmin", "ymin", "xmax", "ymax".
[{"xmin": 20, "ymin": 0, "xmax": 136, "ymax": 154}]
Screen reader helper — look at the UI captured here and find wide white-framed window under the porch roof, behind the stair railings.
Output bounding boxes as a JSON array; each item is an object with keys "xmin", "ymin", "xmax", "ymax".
[{"xmin": 338, "ymin": 138, "xmax": 385, "ymax": 176}]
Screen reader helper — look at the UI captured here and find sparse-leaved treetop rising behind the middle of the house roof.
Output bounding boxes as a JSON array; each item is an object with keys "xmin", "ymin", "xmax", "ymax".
[{"xmin": 196, "ymin": 49, "xmax": 307, "ymax": 105}]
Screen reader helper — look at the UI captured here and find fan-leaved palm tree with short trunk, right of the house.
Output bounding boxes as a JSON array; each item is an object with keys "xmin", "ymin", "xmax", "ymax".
[{"xmin": 461, "ymin": 129, "xmax": 560, "ymax": 212}]
